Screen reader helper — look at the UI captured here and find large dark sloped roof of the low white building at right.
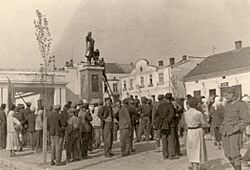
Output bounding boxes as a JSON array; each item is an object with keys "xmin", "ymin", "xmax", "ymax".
[{"xmin": 184, "ymin": 47, "xmax": 250, "ymax": 80}]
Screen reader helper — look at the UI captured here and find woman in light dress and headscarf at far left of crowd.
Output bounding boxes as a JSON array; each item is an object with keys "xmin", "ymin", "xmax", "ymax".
[{"xmin": 6, "ymin": 105, "xmax": 22, "ymax": 157}]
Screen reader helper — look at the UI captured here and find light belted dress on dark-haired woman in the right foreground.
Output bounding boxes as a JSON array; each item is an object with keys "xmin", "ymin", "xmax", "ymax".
[{"xmin": 184, "ymin": 108, "xmax": 207, "ymax": 163}]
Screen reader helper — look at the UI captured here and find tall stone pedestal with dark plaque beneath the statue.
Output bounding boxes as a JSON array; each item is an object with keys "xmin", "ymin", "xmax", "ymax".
[{"xmin": 80, "ymin": 65, "xmax": 103, "ymax": 103}]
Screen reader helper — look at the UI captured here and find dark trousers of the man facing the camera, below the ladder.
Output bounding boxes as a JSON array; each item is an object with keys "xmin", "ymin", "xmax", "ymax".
[{"xmin": 103, "ymin": 122, "xmax": 113, "ymax": 156}]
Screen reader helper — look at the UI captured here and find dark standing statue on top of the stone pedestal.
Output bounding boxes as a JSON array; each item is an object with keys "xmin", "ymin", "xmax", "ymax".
[{"xmin": 85, "ymin": 32, "xmax": 95, "ymax": 64}]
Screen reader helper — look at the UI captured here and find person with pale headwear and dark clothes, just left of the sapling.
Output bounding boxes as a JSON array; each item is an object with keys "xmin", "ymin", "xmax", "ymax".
[{"xmin": 25, "ymin": 107, "xmax": 36, "ymax": 150}]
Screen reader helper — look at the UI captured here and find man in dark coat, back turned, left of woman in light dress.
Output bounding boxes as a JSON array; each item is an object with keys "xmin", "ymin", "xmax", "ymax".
[{"xmin": 155, "ymin": 93, "xmax": 175, "ymax": 160}]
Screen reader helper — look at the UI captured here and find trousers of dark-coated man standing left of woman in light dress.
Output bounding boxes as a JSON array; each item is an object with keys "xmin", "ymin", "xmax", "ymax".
[{"xmin": 161, "ymin": 128, "xmax": 175, "ymax": 158}]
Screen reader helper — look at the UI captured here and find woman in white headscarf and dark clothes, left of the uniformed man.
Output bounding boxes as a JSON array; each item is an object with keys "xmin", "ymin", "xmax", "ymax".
[{"xmin": 210, "ymin": 97, "xmax": 225, "ymax": 149}]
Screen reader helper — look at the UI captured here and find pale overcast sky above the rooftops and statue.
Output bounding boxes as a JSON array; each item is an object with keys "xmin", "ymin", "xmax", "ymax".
[{"xmin": 0, "ymin": 0, "xmax": 250, "ymax": 68}]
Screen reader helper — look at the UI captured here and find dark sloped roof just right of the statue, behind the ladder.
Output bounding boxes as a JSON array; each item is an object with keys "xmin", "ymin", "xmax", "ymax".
[{"xmin": 105, "ymin": 63, "xmax": 135, "ymax": 74}]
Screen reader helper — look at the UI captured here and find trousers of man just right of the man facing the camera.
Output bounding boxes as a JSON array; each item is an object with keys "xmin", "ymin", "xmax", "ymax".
[{"xmin": 120, "ymin": 128, "xmax": 131, "ymax": 156}]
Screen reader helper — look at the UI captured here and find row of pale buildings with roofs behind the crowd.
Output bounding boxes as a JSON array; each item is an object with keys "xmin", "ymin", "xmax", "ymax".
[{"xmin": 0, "ymin": 41, "xmax": 250, "ymax": 106}]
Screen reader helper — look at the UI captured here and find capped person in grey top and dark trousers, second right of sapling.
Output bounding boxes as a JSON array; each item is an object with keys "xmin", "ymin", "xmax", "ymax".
[{"xmin": 66, "ymin": 108, "xmax": 79, "ymax": 162}]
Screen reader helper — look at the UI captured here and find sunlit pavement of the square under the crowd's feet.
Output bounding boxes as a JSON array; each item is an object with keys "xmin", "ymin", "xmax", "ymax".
[{"xmin": 0, "ymin": 141, "xmax": 247, "ymax": 170}]
